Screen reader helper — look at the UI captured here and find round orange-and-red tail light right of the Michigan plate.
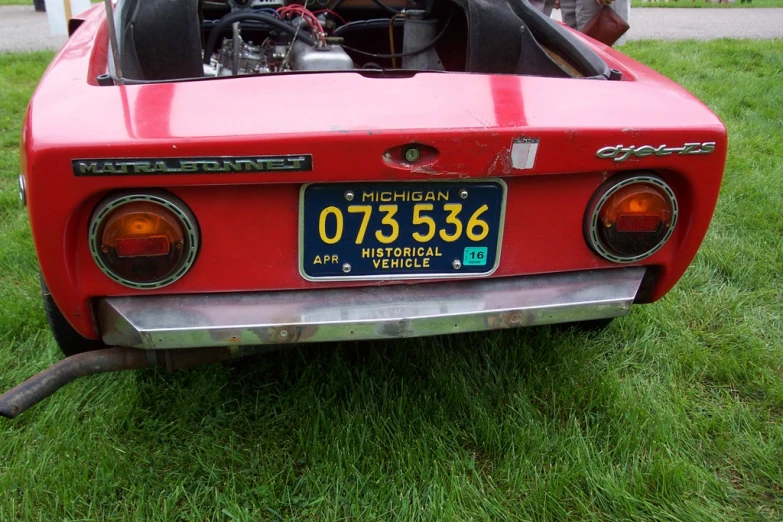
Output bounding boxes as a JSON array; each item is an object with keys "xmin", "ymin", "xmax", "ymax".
[{"xmin": 585, "ymin": 175, "xmax": 677, "ymax": 263}]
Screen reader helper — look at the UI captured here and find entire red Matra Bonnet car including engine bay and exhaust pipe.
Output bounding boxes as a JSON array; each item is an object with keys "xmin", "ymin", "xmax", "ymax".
[{"xmin": 0, "ymin": 0, "xmax": 726, "ymax": 416}]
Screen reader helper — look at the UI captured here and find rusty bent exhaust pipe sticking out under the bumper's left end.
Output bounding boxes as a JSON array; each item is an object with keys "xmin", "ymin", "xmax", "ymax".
[{"xmin": 0, "ymin": 346, "xmax": 268, "ymax": 419}]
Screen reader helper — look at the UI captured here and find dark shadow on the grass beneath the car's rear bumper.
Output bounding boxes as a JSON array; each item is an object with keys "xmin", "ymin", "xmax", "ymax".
[{"xmin": 122, "ymin": 326, "xmax": 616, "ymax": 436}]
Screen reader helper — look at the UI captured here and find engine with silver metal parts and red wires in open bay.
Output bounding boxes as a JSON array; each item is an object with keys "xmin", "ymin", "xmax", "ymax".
[{"xmin": 202, "ymin": 0, "xmax": 450, "ymax": 76}]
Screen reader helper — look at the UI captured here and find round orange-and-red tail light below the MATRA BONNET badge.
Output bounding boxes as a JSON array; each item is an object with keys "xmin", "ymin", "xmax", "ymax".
[{"xmin": 90, "ymin": 193, "xmax": 199, "ymax": 289}]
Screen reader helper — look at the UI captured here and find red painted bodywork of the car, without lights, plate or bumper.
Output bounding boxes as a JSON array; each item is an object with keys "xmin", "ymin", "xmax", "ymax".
[{"xmin": 21, "ymin": 8, "xmax": 727, "ymax": 346}]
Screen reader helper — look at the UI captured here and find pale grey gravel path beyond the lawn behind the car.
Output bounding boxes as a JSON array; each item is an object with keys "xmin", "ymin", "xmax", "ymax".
[{"xmin": 0, "ymin": 5, "xmax": 783, "ymax": 52}]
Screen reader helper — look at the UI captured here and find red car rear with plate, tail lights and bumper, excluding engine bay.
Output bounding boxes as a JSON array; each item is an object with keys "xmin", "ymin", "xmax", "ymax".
[{"xmin": 22, "ymin": 5, "xmax": 726, "ymax": 349}]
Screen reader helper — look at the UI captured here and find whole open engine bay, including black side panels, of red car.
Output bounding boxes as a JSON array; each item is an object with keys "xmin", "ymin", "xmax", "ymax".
[{"xmin": 114, "ymin": 0, "xmax": 615, "ymax": 81}]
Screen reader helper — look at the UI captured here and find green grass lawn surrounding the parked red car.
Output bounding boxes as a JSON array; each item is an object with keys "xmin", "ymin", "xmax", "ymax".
[{"xmin": 0, "ymin": 40, "xmax": 783, "ymax": 522}]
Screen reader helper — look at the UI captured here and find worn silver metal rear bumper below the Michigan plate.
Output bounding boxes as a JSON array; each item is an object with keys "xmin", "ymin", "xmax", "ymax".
[{"xmin": 98, "ymin": 267, "xmax": 644, "ymax": 349}]
